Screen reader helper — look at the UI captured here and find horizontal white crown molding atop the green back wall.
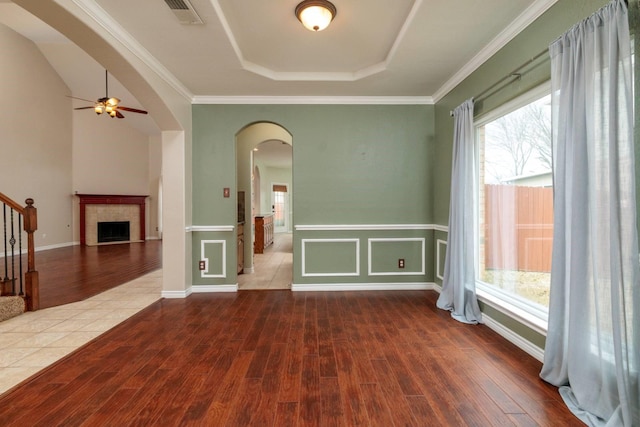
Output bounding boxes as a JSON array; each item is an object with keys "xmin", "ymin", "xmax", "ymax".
[{"xmin": 192, "ymin": 96, "xmax": 434, "ymax": 105}]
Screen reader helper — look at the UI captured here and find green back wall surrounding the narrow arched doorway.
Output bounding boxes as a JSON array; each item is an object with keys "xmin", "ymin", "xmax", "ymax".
[{"xmin": 193, "ymin": 105, "xmax": 435, "ymax": 284}]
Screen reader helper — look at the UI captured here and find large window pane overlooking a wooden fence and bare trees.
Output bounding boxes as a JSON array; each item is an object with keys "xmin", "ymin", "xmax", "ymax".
[{"xmin": 476, "ymin": 86, "xmax": 553, "ymax": 322}]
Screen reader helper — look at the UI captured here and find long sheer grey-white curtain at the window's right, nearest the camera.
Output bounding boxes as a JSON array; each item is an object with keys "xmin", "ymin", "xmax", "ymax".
[{"xmin": 540, "ymin": 0, "xmax": 640, "ymax": 426}]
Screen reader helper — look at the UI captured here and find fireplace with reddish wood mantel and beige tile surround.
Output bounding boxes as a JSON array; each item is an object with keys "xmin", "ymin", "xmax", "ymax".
[{"xmin": 76, "ymin": 194, "xmax": 148, "ymax": 246}]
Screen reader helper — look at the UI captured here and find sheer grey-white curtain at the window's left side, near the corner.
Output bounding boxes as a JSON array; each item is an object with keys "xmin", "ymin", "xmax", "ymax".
[{"xmin": 437, "ymin": 99, "xmax": 482, "ymax": 323}]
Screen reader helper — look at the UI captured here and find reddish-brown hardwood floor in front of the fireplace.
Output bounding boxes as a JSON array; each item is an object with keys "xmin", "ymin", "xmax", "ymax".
[{"xmin": 34, "ymin": 240, "xmax": 162, "ymax": 308}]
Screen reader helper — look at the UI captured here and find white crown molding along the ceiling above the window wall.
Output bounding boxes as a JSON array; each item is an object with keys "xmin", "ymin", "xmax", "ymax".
[{"xmin": 432, "ymin": 0, "xmax": 558, "ymax": 102}]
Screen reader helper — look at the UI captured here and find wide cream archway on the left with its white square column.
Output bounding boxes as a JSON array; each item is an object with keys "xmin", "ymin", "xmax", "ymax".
[{"xmin": 14, "ymin": 0, "xmax": 192, "ymax": 297}]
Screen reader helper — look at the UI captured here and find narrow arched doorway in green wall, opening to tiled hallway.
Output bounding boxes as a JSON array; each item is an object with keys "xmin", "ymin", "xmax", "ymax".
[{"xmin": 236, "ymin": 122, "xmax": 293, "ymax": 290}]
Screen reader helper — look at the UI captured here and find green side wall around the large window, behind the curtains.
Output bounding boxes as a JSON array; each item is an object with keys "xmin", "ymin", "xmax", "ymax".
[{"xmin": 433, "ymin": 0, "xmax": 608, "ymax": 348}]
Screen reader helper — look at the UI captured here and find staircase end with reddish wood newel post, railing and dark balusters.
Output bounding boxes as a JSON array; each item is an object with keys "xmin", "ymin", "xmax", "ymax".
[{"xmin": 0, "ymin": 193, "xmax": 40, "ymax": 321}]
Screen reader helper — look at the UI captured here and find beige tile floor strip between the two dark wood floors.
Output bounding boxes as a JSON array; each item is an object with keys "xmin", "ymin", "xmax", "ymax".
[{"xmin": 0, "ymin": 270, "xmax": 162, "ymax": 393}]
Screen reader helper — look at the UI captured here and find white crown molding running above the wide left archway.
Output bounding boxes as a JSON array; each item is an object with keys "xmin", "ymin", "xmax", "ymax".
[{"xmin": 71, "ymin": 0, "xmax": 193, "ymax": 101}]
